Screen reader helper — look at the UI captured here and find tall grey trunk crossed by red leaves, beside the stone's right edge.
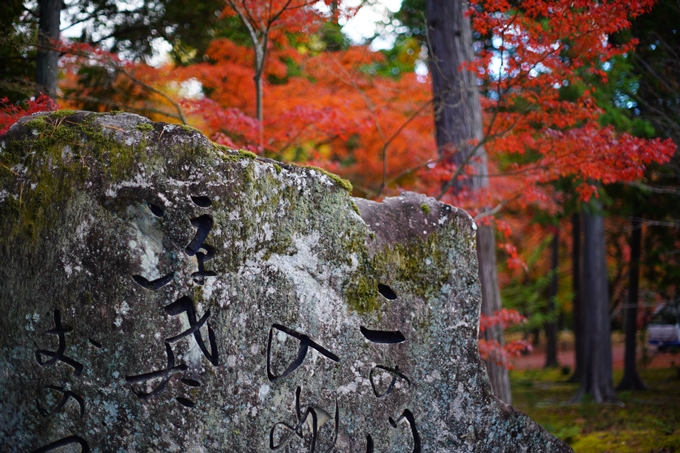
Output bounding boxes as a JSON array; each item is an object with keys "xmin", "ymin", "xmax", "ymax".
[{"xmin": 426, "ymin": 0, "xmax": 511, "ymax": 403}]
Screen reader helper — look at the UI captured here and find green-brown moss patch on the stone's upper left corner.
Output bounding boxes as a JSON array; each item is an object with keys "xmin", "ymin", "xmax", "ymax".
[{"xmin": 0, "ymin": 114, "xmax": 154, "ymax": 241}]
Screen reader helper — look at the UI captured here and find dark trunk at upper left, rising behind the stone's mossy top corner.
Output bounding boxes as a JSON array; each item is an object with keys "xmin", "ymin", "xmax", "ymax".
[{"xmin": 35, "ymin": 0, "xmax": 61, "ymax": 100}]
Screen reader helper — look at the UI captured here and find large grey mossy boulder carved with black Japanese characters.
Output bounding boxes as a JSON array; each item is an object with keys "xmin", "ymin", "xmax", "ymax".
[{"xmin": 0, "ymin": 112, "xmax": 571, "ymax": 453}]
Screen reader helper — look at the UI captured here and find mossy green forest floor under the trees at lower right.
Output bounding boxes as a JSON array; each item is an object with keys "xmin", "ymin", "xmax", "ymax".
[{"xmin": 510, "ymin": 334, "xmax": 680, "ymax": 453}]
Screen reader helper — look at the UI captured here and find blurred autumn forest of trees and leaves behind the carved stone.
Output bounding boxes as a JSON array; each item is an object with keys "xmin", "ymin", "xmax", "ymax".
[{"xmin": 0, "ymin": 0, "xmax": 680, "ymax": 451}]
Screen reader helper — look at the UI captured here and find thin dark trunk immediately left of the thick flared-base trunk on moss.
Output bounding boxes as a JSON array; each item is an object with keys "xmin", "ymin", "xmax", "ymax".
[{"xmin": 569, "ymin": 213, "xmax": 583, "ymax": 382}]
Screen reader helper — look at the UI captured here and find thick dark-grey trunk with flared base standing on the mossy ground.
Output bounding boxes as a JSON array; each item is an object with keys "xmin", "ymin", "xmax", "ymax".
[{"xmin": 574, "ymin": 200, "xmax": 617, "ymax": 403}]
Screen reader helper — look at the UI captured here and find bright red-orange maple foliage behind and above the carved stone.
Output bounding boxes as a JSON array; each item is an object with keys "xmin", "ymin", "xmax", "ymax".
[{"xmin": 7, "ymin": 0, "xmax": 675, "ymax": 363}]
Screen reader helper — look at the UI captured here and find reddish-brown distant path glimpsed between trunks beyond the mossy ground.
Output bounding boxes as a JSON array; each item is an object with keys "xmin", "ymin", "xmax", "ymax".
[{"xmin": 512, "ymin": 343, "xmax": 680, "ymax": 371}]
